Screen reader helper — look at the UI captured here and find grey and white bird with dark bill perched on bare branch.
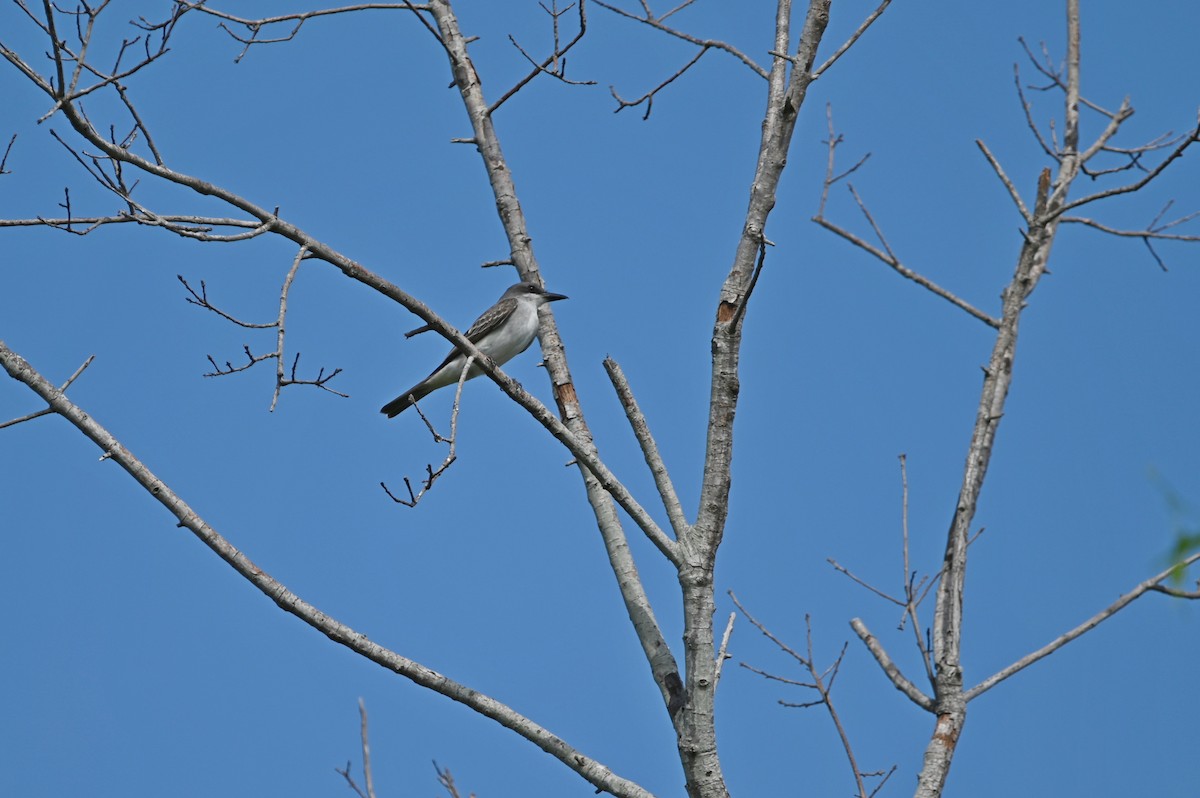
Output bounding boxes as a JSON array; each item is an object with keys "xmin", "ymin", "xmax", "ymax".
[{"xmin": 379, "ymin": 283, "xmax": 566, "ymax": 419}]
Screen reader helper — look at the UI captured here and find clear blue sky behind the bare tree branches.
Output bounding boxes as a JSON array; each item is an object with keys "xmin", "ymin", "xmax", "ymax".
[{"xmin": 0, "ymin": 0, "xmax": 1200, "ymax": 798}]
